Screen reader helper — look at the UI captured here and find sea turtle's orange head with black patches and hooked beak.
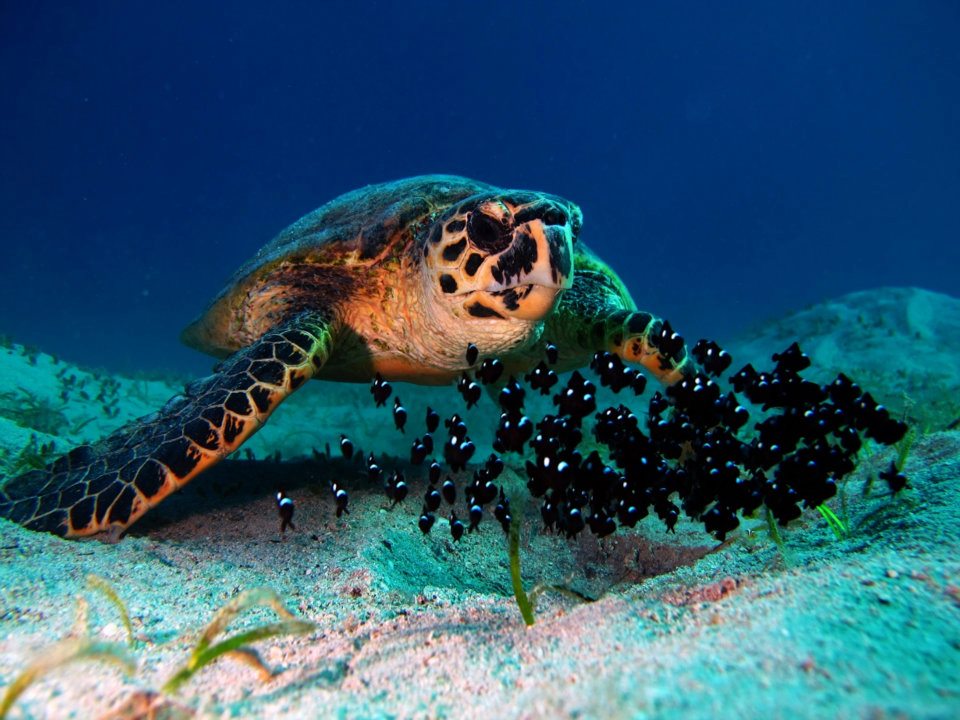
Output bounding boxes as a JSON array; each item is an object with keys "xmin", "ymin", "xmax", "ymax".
[{"xmin": 423, "ymin": 191, "xmax": 582, "ymax": 321}]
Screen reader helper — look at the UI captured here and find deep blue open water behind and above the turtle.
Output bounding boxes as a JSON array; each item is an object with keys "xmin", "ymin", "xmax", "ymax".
[{"xmin": 0, "ymin": 0, "xmax": 960, "ymax": 371}]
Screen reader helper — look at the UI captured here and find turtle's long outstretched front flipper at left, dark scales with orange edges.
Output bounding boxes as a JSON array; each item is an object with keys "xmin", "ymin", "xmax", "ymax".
[{"xmin": 0, "ymin": 313, "xmax": 331, "ymax": 537}]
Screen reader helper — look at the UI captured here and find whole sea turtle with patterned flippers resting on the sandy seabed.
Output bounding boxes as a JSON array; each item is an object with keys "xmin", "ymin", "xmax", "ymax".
[{"xmin": 0, "ymin": 175, "xmax": 693, "ymax": 537}]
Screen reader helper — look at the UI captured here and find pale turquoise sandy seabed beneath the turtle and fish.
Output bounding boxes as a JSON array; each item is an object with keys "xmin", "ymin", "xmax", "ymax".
[{"xmin": 0, "ymin": 290, "xmax": 960, "ymax": 718}]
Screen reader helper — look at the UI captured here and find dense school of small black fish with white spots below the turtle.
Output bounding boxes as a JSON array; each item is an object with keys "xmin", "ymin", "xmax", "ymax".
[{"xmin": 330, "ymin": 333, "xmax": 908, "ymax": 541}]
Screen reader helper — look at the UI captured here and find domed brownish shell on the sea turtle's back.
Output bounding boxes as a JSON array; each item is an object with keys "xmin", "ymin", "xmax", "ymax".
[{"xmin": 181, "ymin": 175, "xmax": 495, "ymax": 356}]
